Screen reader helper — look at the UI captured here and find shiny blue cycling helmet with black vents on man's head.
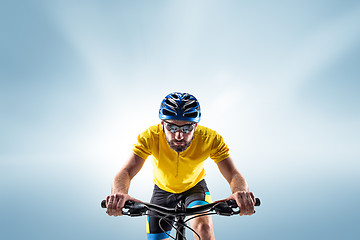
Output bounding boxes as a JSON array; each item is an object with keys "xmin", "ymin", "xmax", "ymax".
[{"xmin": 159, "ymin": 92, "xmax": 201, "ymax": 123}]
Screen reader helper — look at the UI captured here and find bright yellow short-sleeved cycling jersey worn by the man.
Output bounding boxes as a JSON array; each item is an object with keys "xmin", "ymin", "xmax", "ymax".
[{"xmin": 133, "ymin": 124, "xmax": 230, "ymax": 193}]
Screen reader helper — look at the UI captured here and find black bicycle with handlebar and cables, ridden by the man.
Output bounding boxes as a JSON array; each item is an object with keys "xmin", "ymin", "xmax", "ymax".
[{"xmin": 101, "ymin": 198, "xmax": 260, "ymax": 240}]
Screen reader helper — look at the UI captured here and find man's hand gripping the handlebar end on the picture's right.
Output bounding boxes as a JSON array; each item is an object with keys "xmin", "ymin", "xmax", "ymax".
[{"xmin": 226, "ymin": 191, "xmax": 255, "ymax": 216}]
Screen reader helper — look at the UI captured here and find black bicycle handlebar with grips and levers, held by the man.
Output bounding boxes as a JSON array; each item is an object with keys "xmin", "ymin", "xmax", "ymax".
[{"xmin": 101, "ymin": 198, "xmax": 261, "ymax": 217}]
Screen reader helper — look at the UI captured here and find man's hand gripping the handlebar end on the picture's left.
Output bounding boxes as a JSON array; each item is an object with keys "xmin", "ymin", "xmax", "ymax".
[{"xmin": 106, "ymin": 193, "xmax": 140, "ymax": 217}]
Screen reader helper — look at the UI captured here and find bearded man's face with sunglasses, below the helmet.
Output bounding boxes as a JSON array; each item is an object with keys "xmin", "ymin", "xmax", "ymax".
[{"xmin": 161, "ymin": 120, "xmax": 196, "ymax": 152}]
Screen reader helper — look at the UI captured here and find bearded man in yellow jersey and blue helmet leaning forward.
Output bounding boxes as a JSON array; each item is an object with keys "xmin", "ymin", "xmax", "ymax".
[{"xmin": 106, "ymin": 92, "xmax": 255, "ymax": 240}]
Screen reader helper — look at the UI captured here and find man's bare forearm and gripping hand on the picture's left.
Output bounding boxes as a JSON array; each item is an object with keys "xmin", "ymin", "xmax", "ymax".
[{"xmin": 106, "ymin": 153, "xmax": 145, "ymax": 216}]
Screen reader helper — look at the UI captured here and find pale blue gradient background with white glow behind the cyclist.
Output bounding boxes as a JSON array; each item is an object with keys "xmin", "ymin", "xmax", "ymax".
[{"xmin": 0, "ymin": 0, "xmax": 360, "ymax": 240}]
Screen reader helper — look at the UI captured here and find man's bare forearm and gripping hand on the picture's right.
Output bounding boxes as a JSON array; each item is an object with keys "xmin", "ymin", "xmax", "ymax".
[{"xmin": 217, "ymin": 157, "xmax": 255, "ymax": 215}]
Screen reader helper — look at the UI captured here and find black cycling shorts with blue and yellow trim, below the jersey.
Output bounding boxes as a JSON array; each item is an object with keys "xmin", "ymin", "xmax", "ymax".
[{"xmin": 146, "ymin": 179, "xmax": 211, "ymax": 240}]
